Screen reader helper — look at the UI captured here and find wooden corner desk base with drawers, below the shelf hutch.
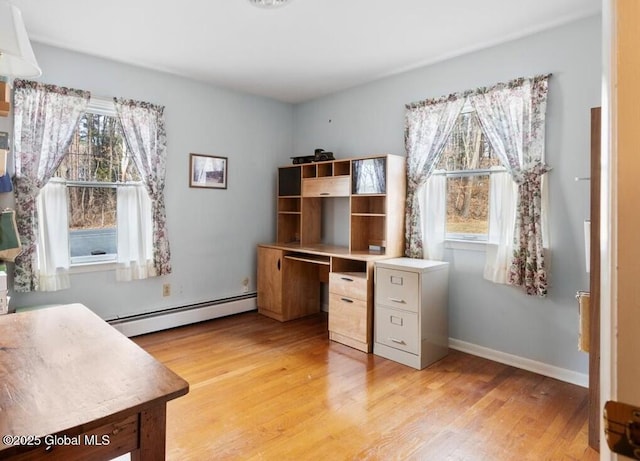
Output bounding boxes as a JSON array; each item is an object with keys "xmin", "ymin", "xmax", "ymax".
[{"xmin": 257, "ymin": 243, "xmax": 391, "ymax": 352}]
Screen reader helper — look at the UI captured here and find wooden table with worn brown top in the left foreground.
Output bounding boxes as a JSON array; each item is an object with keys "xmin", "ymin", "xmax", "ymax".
[{"xmin": 0, "ymin": 304, "xmax": 189, "ymax": 461}]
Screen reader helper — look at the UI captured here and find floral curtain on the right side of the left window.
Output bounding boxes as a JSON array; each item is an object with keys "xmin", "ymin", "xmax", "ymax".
[{"xmin": 114, "ymin": 98, "xmax": 171, "ymax": 275}]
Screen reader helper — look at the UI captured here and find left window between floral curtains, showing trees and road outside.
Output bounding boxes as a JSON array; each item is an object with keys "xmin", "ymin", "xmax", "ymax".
[{"xmin": 54, "ymin": 99, "xmax": 140, "ymax": 265}]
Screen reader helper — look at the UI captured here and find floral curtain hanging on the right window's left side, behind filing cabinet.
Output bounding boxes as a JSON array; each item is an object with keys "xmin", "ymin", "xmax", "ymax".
[{"xmin": 405, "ymin": 95, "xmax": 465, "ymax": 258}]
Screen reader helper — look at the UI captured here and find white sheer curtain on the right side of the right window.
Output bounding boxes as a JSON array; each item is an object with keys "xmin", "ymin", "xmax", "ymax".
[{"xmin": 484, "ymin": 167, "xmax": 518, "ymax": 283}]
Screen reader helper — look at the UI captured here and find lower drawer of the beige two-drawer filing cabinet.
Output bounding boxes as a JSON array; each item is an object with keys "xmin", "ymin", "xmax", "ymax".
[{"xmin": 375, "ymin": 306, "xmax": 419, "ymax": 354}]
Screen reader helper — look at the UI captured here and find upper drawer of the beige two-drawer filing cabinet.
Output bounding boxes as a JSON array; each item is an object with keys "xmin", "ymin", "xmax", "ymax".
[{"xmin": 375, "ymin": 267, "xmax": 420, "ymax": 312}]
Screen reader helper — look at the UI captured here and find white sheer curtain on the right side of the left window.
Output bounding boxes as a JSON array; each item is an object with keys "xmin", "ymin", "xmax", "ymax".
[{"xmin": 116, "ymin": 183, "xmax": 156, "ymax": 282}]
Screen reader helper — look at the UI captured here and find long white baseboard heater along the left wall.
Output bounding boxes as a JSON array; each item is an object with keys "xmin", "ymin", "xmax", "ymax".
[{"xmin": 108, "ymin": 293, "xmax": 257, "ymax": 337}]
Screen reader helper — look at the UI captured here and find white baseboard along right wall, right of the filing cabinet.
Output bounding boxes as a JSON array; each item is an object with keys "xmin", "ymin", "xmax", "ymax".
[{"xmin": 449, "ymin": 338, "xmax": 589, "ymax": 388}]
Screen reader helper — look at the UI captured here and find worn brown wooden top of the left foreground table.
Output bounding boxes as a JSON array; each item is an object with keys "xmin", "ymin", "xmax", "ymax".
[{"xmin": 0, "ymin": 304, "xmax": 189, "ymax": 448}]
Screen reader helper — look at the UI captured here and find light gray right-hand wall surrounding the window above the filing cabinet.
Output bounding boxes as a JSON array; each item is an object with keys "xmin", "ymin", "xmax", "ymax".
[{"xmin": 294, "ymin": 17, "xmax": 601, "ymax": 373}]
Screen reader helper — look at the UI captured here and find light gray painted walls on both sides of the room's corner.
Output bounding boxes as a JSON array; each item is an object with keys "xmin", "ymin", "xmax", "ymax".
[{"xmin": 0, "ymin": 17, "xmax": 600, "ymax": 373}]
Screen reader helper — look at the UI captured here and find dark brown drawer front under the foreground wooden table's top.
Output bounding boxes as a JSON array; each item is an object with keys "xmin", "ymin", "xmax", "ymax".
[{"xmin": 10, "ymin": 414, "xmax": 138, "ymax": 461}]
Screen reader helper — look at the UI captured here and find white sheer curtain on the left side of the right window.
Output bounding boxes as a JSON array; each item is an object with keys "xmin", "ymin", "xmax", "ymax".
[{"xmin": 419, "ymin": 170, "xmax": 447, "ymax": 261}]
